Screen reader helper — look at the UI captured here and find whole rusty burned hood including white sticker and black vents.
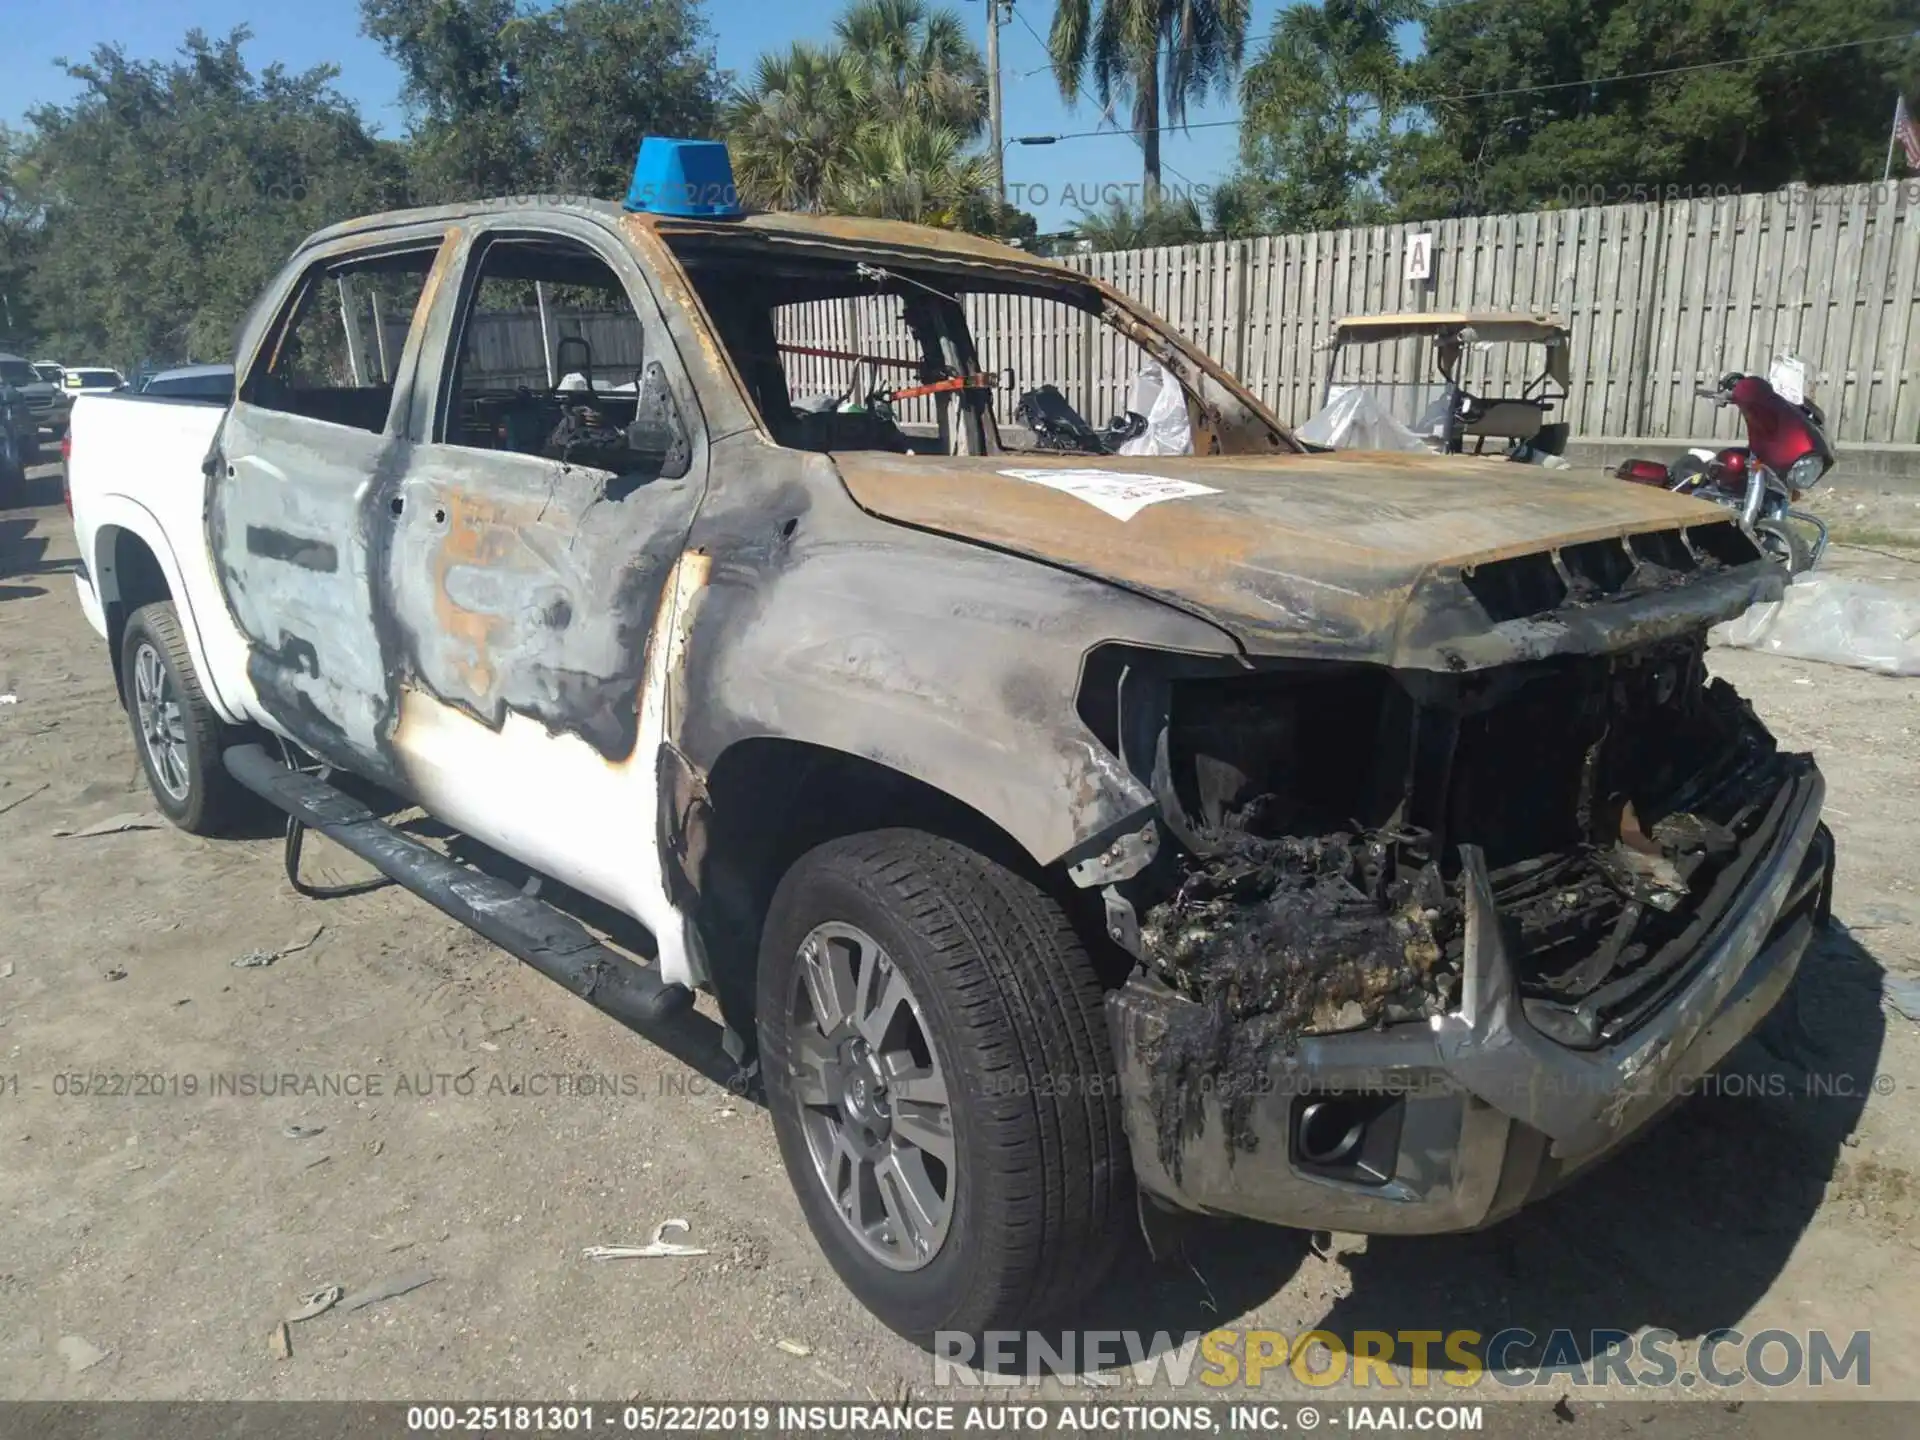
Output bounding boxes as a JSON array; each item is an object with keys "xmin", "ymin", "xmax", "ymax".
[{"xmin": 833, "ymin": 451, "xmax": 1782, "ymax": 670}]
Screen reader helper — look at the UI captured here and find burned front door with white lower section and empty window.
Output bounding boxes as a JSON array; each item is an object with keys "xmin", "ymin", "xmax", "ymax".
[{"xmin": 378, "ymin": 213, "xmax": 708, "ymax": 983}]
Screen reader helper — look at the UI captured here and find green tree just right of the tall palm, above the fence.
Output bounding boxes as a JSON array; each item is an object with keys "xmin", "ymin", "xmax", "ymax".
[{"xmin": 1213, "ymin": 0, "xmax": 1425, "ymax": 234}]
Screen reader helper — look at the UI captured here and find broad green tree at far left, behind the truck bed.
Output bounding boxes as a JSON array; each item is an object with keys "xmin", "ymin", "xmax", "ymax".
[{"xmin": 25, "ymin": 29, "xmax": 403, "ymax": 367}]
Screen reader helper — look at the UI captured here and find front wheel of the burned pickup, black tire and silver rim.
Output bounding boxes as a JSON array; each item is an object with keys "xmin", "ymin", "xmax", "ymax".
[{"xmin": 756, "ymin": 829, "xmax": 1133, "ymax": 1344}]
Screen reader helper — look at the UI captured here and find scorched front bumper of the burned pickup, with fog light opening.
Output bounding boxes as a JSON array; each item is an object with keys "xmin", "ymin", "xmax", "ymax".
[{"xmin": 1106, "ymin": 762, "xmax": 1832, "ymax": 1235}]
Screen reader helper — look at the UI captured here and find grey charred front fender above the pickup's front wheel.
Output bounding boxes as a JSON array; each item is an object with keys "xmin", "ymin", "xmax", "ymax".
[{"xmin": 670, "ymin": 445, "xmax": 1236, "ymax": 883}]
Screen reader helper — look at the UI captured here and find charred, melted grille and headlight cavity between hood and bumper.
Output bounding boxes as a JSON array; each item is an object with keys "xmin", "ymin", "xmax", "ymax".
[{"xmin": 1113, "ymin": 637, "xmax": 1805, "ymax": 1052}]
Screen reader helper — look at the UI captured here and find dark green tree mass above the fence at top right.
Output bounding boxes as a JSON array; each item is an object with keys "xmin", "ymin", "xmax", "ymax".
[{"xmin": 1386, "ymin": 0, "xmax": 1920, "ymax": 217}]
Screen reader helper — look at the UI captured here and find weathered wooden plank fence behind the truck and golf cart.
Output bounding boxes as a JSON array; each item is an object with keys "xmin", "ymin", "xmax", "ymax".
[{"xmin": 780, "ymin": 180, "xmax": 1920, "ymax": 444}]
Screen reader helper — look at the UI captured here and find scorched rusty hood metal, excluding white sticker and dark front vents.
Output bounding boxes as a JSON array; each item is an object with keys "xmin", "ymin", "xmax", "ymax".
[{"xmin": 835, "ymin": 455, "xmax": 1780, "ymax": 670}]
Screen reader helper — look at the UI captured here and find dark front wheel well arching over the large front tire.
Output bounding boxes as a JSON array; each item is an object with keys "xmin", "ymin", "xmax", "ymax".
[{"xmin": 695, "ymin": 737, "xmax": 1131, "ymax": 1037}]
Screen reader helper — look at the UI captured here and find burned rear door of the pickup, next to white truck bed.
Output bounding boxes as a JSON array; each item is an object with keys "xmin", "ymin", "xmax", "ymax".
[{"xmin": 205, "ymin": 221, "xmax": 459, "ymax": 789}]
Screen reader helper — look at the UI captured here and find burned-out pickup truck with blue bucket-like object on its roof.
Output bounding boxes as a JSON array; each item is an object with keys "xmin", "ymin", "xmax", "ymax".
[{"xmin": 71, "ymin": 142, "xmax": 1830, "ymax": 1336}]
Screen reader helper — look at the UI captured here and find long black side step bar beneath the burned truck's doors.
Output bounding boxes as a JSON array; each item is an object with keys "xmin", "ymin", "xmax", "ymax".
[{"xmin": 223, "ymin": 745, "xmax": 693, "ymax": 1036}]
